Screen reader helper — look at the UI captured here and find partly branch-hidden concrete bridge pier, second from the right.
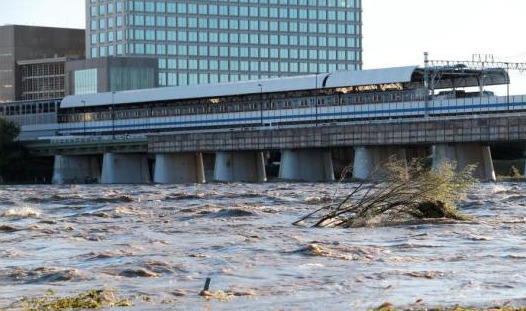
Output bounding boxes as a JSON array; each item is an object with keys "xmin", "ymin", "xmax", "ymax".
[{"xmin": 353, "ymin": 146, "xmax": 407, "ymax": 180}]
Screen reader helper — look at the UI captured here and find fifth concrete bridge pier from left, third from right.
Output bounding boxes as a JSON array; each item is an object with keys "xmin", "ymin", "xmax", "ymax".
[{"xmin": 279, "ymin": 149, "xmax": 334, "ymax": 182}]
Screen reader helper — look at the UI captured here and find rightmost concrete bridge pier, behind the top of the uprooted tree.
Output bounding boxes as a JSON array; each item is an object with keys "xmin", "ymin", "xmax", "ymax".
[{"xmin": 433, "ymin": 143, "xmax": 497, "ymax": 181}]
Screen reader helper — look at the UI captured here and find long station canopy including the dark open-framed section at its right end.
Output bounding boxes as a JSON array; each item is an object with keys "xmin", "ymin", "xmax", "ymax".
[{"xmin": 62, "ymin": 66, "xmax": 509, "ymax": 108}]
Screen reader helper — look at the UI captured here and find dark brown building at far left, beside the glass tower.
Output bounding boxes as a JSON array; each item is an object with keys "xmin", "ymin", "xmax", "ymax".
[{"xmin": 0, "ymin": 25, "xmax": 85, "ymax": 103}]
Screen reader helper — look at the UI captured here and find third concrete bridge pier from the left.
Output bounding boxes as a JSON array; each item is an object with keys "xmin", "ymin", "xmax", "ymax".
[{"xmin": 154, "ymin": 153, "xmax": 206, "ymax": 184}]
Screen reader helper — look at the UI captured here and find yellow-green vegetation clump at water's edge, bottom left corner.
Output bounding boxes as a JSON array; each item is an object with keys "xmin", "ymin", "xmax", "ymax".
[{"xmin": 20, "ymin": 290, "xmax": 133, "ymax": 311}]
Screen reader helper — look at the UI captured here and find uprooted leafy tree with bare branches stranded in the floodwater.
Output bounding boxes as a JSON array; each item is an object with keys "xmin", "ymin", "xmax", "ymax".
[{"xmin": 294, "ymin": 158, "xmax": 477, "ymax": 228}]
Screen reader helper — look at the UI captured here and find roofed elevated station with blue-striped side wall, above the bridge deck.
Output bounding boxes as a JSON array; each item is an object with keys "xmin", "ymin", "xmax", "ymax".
[{"xmin": 0, "ymin": 66, "xmax": 526, "ymax": 141}]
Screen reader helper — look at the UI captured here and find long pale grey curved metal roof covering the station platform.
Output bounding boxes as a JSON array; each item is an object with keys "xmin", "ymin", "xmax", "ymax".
[{"xmin": 61, "ymin": 66, "xmax": 509, "ymax": 108}]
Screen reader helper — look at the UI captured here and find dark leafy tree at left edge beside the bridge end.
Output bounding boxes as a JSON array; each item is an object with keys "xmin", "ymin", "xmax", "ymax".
[{"xmin": 0, "ymin": 118, "xmax": 30, "ymax": 182}]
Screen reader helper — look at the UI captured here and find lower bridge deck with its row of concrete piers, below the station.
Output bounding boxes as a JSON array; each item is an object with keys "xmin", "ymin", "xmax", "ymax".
[{"xmin": 29, "ymin": 112, "xmax": 526, "ymax": 184}]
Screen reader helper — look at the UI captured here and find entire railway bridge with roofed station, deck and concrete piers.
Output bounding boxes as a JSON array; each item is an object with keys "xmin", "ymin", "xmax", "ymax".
[{"xmin": 0, "ymin": 66, "xmax": 526, "ymax": 184}]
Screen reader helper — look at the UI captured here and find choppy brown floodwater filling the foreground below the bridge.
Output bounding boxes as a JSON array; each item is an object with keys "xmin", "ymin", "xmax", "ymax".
[{"xmin": 0, "ymin": 183, "xmax": 526, "ymax": 310}]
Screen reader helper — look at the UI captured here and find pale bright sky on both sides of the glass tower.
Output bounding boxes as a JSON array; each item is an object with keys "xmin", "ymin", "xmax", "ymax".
[{"xmin": 0, "ymin": 0, "xmax": 526, "ymax": 94}]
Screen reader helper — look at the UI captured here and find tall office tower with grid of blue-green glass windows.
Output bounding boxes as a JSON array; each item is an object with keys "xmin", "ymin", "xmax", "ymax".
[{"xmin": 86, "ymin": 0, "xmax": 362, "ymax": 86}]
